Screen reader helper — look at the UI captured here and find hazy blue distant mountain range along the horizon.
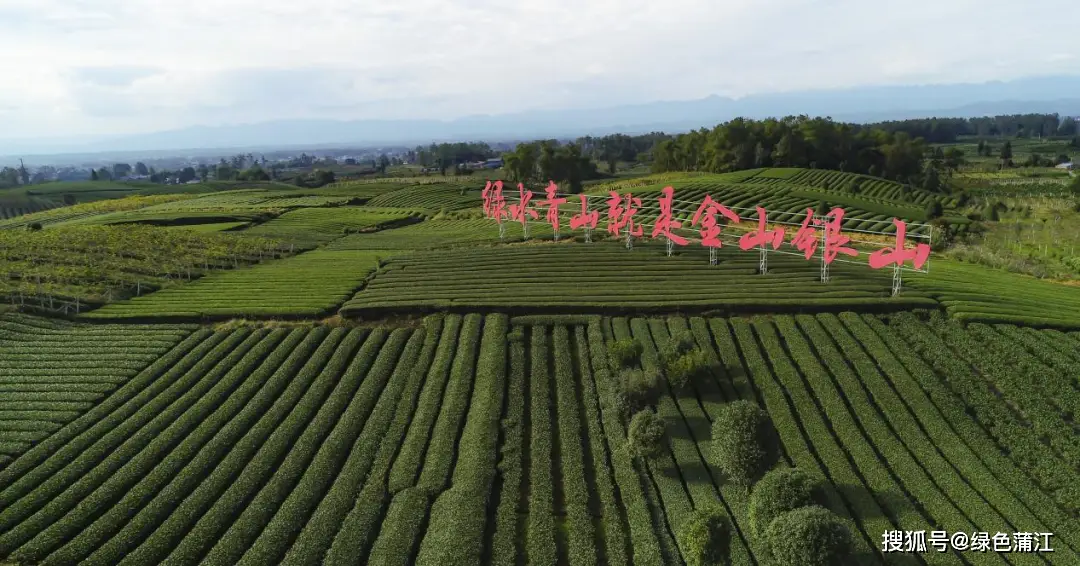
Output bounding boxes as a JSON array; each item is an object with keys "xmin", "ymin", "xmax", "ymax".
[{"xmin": 0, "ymin": 76, "xmax": 1080, "ymax": 161}]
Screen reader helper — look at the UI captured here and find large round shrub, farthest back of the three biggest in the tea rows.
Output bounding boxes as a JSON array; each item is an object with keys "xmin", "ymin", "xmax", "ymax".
[{"xmin": 713, "ymin": 401, "xmax": 780, "ymax": 485}]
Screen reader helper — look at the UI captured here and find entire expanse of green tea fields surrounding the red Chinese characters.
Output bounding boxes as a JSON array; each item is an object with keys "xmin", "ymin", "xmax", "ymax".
[{"xmin": 0, "ymin": 169, "xmax": 1080, "ymax": 566}]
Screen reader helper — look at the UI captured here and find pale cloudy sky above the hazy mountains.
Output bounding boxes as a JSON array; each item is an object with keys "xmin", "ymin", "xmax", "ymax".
[{"xmin": 0, "ymin": 0, "xmax": 1080, "ymax": 138}]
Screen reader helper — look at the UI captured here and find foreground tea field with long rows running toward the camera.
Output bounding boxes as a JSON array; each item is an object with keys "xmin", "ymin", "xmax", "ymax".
[{"xmin": 0, "ymin": 313, "xmax": 1080, "ymax": 564}]
